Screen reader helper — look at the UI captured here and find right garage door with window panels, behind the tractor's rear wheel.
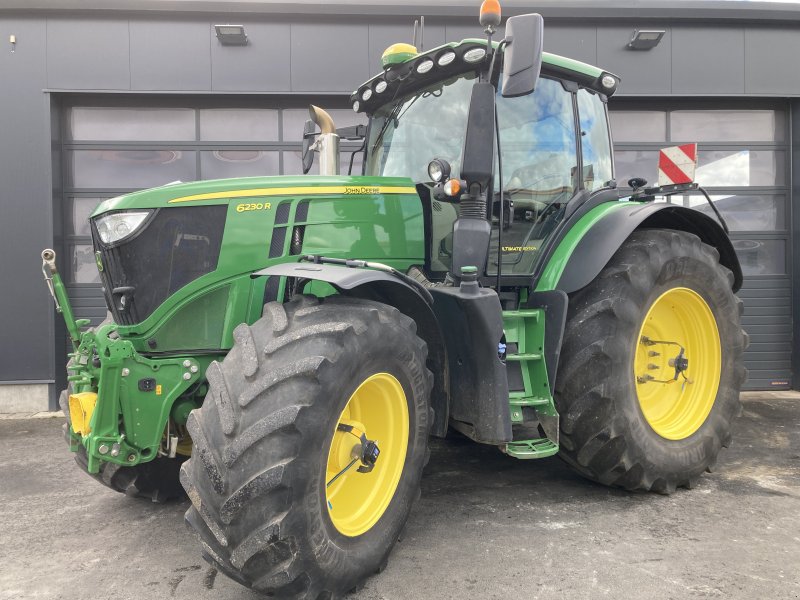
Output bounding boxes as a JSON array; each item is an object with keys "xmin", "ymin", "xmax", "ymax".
[{"xmin": 611, "ymin": 99, "xmax": 792, "ymax": 389}]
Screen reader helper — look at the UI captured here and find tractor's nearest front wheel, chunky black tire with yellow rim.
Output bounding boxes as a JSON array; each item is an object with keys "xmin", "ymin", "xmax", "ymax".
[{"xmin": 181, "ymin": 297, "xmax": 432, "ymax": 599}]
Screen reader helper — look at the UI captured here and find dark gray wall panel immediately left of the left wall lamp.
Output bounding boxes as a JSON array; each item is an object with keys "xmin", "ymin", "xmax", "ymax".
[{"xmin": 130, "ymin": 21, "xmax": 211, "ymax": 90}]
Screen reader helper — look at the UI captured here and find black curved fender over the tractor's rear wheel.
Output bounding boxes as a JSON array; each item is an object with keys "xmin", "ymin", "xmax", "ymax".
[{"xmin": 548, "ymin": 202, "xmax": 742, "ymax": 294}]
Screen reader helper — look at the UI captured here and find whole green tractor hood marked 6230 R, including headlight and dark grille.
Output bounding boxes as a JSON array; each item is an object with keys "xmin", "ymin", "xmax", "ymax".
[{"xmin": 90, "ymin": 176, "xmax": 425, "ymax": 340}]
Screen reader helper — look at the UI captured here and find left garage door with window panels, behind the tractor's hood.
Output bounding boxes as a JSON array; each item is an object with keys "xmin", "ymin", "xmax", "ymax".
[{"xmin": 57, "ymin": 96, "xmax": 363, "ymax": 350}]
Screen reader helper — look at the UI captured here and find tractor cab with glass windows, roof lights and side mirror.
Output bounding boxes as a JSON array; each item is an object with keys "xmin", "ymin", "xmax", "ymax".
[{"xmin": 315, "ymin": 15, "xmax": 618, "ymax": 289}]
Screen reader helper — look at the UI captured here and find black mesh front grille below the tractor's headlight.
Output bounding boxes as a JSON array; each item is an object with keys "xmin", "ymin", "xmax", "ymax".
[{"xmin": 92, "ymin": 204, "xmax": 227, "ymax": 325}]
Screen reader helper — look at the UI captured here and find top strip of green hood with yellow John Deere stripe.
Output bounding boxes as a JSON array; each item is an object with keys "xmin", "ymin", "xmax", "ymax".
[{"xmin": 92, "ymin": 175, "xmax": 416, "ymax": 218}]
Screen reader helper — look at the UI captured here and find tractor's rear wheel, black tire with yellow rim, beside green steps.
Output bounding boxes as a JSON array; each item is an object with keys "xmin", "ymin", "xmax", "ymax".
[{"xmin": 555, "ymin": 229, "xmax": 747, "ymax": 493}]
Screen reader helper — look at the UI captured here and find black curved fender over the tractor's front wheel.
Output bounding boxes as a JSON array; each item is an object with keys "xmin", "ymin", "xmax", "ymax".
[{"xmin": 253, "ymin": 263, "xmax": 450, "ymax": 437}]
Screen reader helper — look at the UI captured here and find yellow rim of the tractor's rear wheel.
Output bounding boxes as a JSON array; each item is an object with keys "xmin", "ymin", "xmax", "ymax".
[{"xmin": 633, "ymin": 287, "xmax": 722, "ymax": 440}]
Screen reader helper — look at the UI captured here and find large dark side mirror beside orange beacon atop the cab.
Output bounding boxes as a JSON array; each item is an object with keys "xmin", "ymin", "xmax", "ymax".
[{"xmin": 502, "ymin": 13, "xmax": 544, "ymax": 98}]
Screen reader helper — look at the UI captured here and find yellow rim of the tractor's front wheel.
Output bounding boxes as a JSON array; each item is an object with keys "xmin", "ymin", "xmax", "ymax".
[{"xmin": 325, "ymin": 373, "xmax": 409, "ymax": 537}]
